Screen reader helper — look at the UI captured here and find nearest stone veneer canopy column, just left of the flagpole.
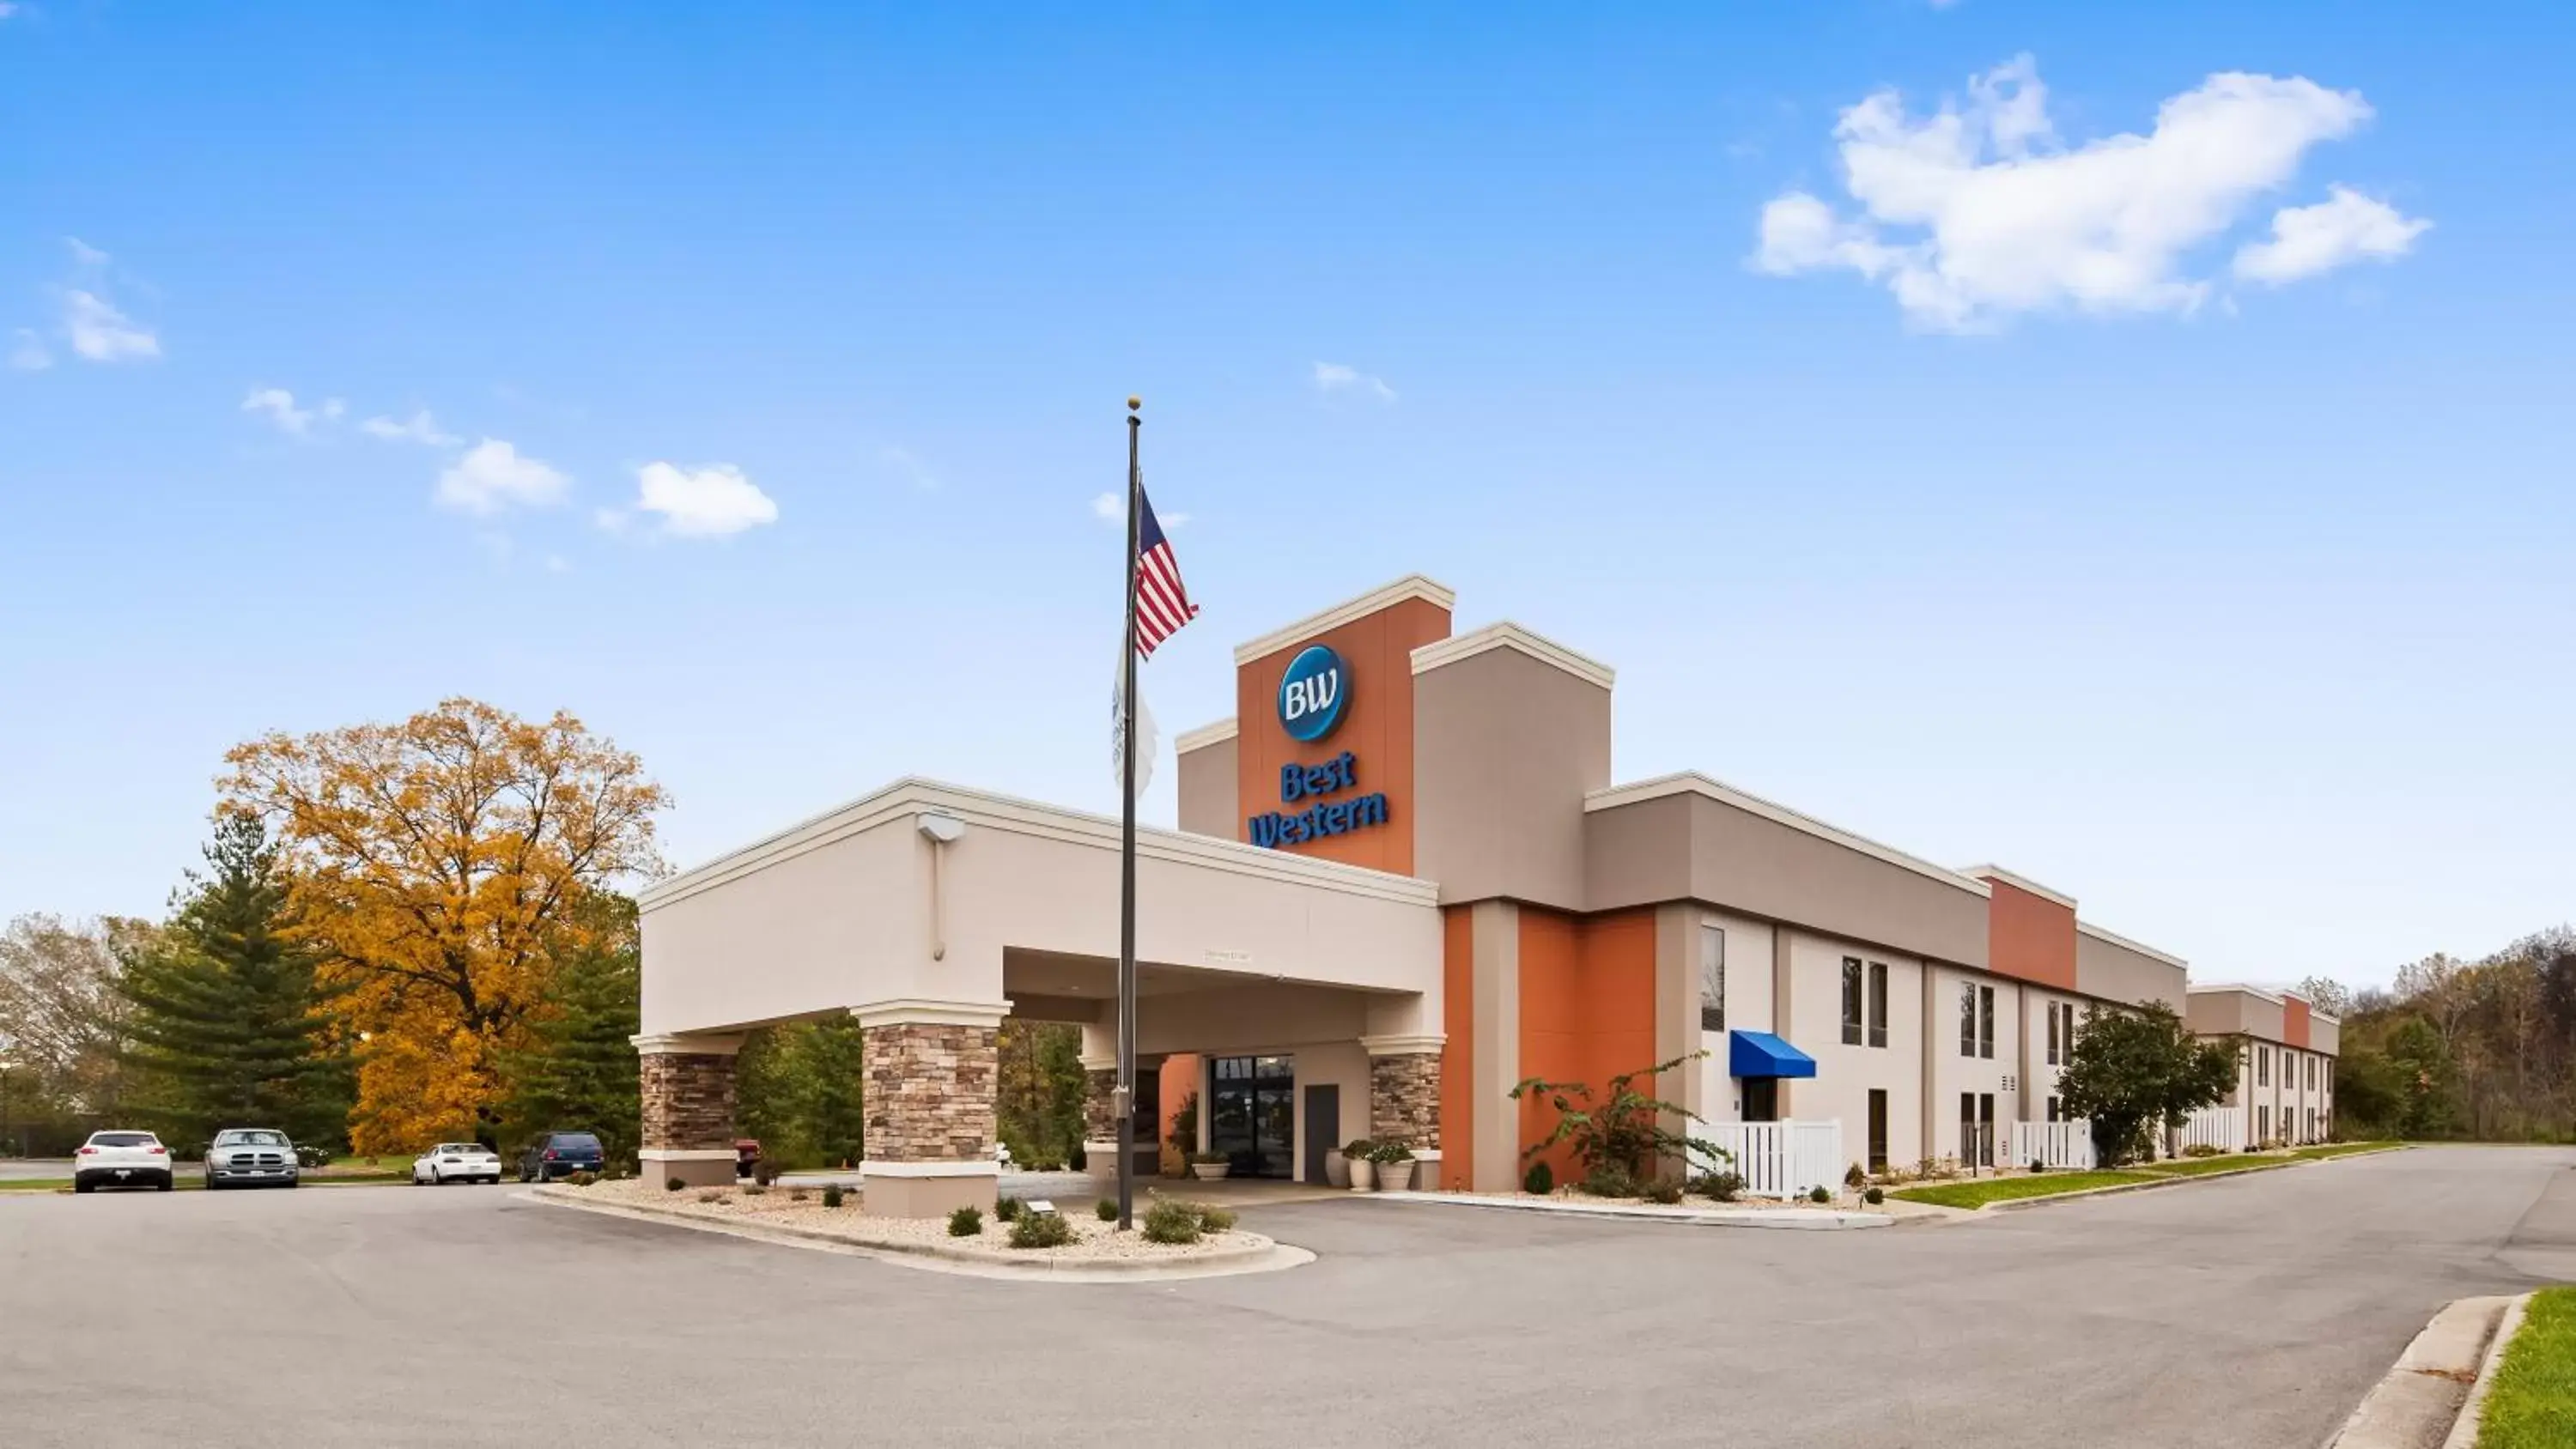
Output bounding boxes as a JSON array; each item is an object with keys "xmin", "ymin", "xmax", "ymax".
[{"xmin": 853, "ymin": 998, "xmax": 1010, "ymax": 1217}]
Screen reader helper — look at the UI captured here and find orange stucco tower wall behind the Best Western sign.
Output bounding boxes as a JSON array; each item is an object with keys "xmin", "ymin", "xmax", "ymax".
[{"xmin": 1234, "ymin": 600, "xmax": 1450, "ymax": 875}]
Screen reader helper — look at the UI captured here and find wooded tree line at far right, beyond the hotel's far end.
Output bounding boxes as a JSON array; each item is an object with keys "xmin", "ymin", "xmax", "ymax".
[{"xmin": 2300, "ymin": 926, "xmax": 2576, "ymax": 1143}]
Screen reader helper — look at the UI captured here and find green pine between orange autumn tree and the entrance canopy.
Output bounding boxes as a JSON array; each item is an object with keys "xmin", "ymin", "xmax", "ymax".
[{"xmin": 497, "ymin": 893, "xmax": 641, "ymax": 1163}]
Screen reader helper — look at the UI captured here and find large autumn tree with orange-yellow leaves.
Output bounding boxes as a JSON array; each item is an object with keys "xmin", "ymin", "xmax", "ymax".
[{"xmin": 219, "ymin": 700, "xmax": 665, "ymax": 1153}]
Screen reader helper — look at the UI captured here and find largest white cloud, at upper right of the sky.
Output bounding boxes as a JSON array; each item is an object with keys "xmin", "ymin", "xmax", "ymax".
[{"xmin": 1752, "ymin": 57, "xmax": 2370, "ymax": 332}]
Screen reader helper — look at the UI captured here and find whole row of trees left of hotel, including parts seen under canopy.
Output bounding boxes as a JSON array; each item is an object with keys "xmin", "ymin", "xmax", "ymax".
[{"xmin": 0, "ymin": 700, "xmax": 1082, "ymax": 1166}]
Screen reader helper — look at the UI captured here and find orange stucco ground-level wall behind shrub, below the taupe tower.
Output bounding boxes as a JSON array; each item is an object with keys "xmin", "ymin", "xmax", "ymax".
[{"xmin": 1515, "ymin": 906, "xmax": 1656, "ymax": 1184}]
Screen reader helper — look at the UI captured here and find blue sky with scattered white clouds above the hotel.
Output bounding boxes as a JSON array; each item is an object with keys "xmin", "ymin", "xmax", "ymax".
[{"xmin": 0, "ymin": 0, "xmax": 2576, "ymax": 980}]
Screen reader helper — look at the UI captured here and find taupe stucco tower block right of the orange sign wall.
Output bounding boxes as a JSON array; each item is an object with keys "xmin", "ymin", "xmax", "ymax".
[{"xmin": 1414, "ymin": 631, "xmax": 1610, "ymax": 911}]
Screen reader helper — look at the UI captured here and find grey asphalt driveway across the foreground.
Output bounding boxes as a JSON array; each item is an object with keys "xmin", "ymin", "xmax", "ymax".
[{"xmin": 0, "ymin": 1148, "xmax": 2576, "ymax": 1449}]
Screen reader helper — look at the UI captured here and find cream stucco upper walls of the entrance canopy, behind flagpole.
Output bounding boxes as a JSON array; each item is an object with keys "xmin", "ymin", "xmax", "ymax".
[{"xmin": 641, "ymin": 779, "xmax": 1440, "ymax": 1032}]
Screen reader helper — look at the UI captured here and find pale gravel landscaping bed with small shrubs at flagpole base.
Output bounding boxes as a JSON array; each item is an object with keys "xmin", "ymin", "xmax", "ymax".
[{"xmin": 556, "ymin": 1179, "xmax": 1273, "ymax": 1266}]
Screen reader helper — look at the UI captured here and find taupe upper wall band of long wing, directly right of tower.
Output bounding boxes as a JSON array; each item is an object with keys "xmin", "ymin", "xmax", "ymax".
[{"xmin": 1584, "ymin": 792, "xmax": 1989, "ymax": 965}]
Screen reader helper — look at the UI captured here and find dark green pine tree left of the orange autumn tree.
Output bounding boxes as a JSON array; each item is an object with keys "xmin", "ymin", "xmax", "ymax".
[{"xmin": 118, "ymin": 815, "xmax": 350, "ymax": 1145}]
